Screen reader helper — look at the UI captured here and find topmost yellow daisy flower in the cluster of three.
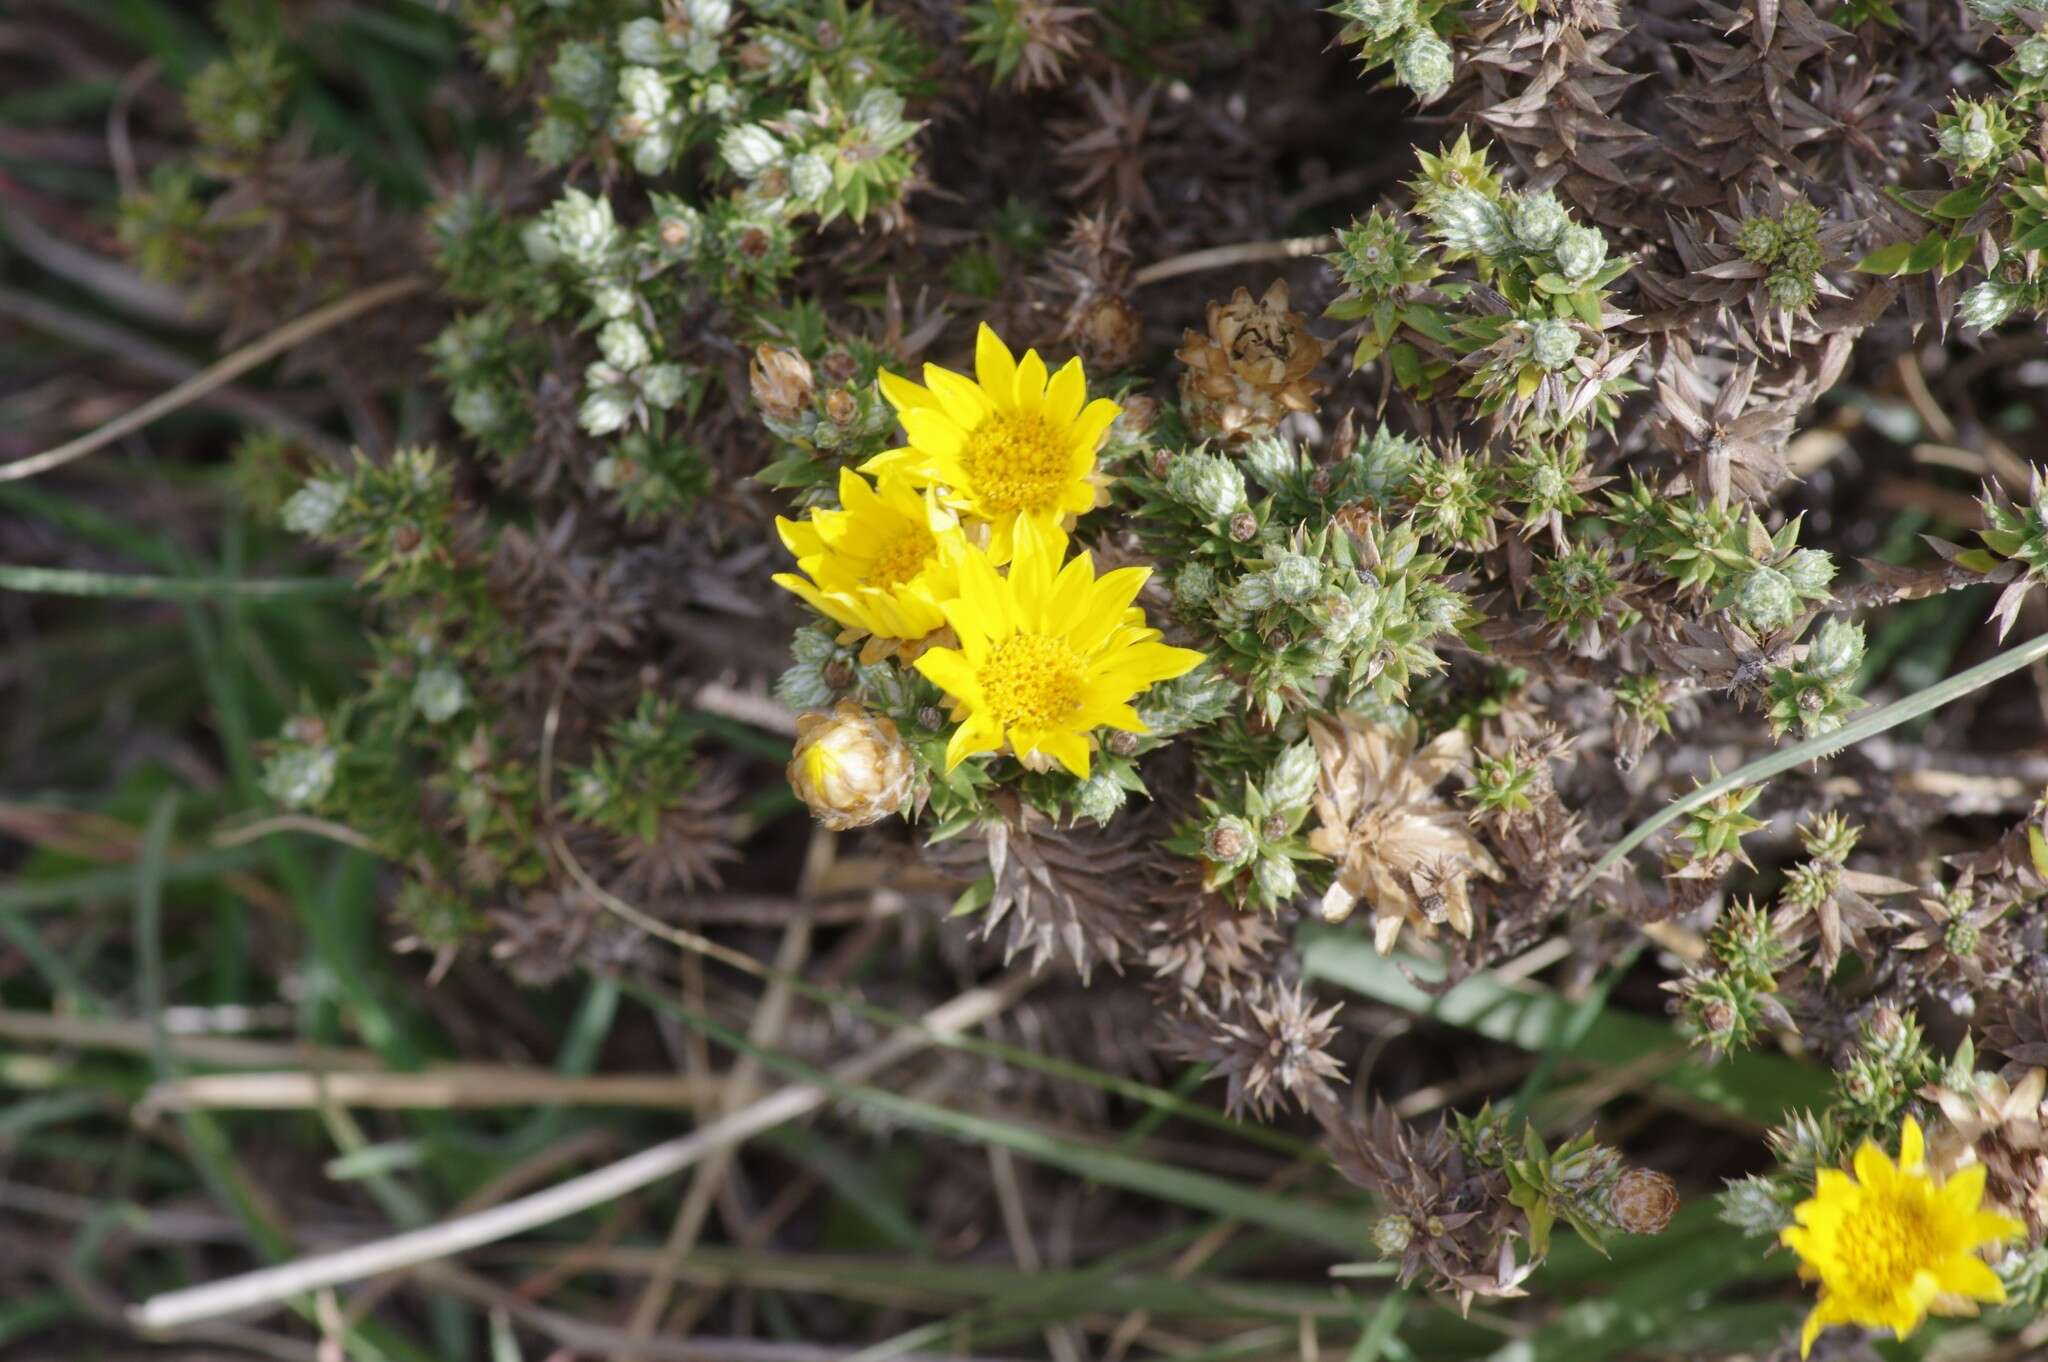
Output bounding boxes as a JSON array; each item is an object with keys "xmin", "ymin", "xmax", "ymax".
[{"xmin": 862, "ymin": 322, "xmax": 1120, "ymax": 561}]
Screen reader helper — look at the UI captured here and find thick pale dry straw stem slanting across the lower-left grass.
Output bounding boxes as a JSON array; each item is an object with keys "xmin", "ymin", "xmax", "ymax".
[{"xmin": 129, "ymin": 969, "xmax": 1032, "ymax": 1333}]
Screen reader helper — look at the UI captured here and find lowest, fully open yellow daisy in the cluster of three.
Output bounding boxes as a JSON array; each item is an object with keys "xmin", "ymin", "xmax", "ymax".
[{"xmin": 915, "ymin": 516, "xmax": 1202, "ymax": 776}]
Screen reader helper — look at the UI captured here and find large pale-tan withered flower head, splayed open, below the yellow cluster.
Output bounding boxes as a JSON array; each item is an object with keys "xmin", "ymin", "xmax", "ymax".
[{"xmin": 1309, "ymin": 717, "xmax": 1501, "ymax": 954}]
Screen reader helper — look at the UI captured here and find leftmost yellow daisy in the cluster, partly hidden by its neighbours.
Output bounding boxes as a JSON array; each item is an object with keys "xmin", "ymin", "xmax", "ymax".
[{"xmin": 774, "ymin": 469, "xmax": 967, "ymax": 662}]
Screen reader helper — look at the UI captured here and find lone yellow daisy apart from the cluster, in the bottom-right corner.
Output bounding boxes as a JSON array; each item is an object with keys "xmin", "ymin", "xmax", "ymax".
[{"xmin": 1780, "ymin": 1116, "xmax": 2023, "ymax": 1358}]
